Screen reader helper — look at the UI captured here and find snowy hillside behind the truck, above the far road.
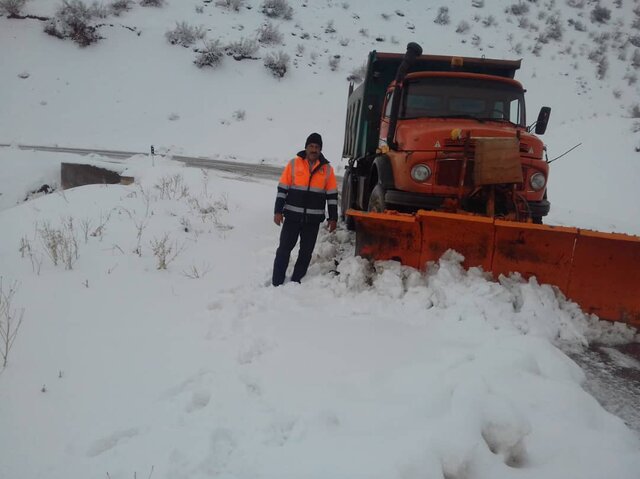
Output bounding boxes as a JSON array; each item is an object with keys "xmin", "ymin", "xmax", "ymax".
[{"xmin": 0, "ymin": 0, "xmax": 640, "ymax": 234}]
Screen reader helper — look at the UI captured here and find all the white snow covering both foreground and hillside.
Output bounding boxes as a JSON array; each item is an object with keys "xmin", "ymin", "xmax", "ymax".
[{"xmin": 0, "ymin": 0, "xmax": 640, "ymax": 479}]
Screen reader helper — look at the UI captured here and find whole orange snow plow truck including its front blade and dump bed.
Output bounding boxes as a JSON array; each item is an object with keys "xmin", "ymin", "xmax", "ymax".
[{"xmin": 341, "ymin": 43, "xmax": 640, "ymax": 327}]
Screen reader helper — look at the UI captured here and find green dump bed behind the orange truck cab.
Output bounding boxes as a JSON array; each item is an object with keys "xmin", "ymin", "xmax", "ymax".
[{"xmin": 342, "ymin": 50, "xmax": 520, "ymax": 158}]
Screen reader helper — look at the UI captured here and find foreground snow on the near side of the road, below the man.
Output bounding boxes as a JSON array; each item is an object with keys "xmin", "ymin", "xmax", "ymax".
[{"xmin": 0, "ymin": 152, "xmax": 640, "ymax": 479}]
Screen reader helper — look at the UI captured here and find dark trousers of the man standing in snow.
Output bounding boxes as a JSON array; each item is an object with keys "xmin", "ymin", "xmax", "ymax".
[{"xmin": 271, "ymin": 219, "xmax": 320, "ymax": 286}]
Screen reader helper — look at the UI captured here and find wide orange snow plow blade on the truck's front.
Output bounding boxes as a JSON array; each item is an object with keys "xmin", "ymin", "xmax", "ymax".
[{"xmin": 347, "ymin": 210, "xmax": 640, "ymax": 327}]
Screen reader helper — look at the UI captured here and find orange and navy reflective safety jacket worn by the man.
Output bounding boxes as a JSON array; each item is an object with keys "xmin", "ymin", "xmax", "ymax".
[{"xmin": 274, "ymin": 150, "xmax": 338, "ymax": 223}]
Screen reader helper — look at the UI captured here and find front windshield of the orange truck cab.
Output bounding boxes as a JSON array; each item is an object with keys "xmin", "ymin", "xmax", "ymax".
[{"xmin": 399, "ymin": 78, "xmax": 526, "ymax": 126}]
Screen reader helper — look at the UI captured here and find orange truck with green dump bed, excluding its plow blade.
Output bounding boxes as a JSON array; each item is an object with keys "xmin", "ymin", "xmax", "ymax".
[{"xmin": 342, "ymin": 44, "xmax": 550, "ymax": 226}]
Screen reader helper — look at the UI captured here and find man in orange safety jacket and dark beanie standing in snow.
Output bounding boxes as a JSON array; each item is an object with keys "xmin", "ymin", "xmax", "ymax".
[{"xmin": 271, "ymin": 133, "xmax": 338, "ymax": 286}]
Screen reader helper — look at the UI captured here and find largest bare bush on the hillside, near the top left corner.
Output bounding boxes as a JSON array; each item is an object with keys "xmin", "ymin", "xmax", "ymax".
[{"xmin": 44, "ymin": 0, "xmax": 102, "ymax": 47}]
